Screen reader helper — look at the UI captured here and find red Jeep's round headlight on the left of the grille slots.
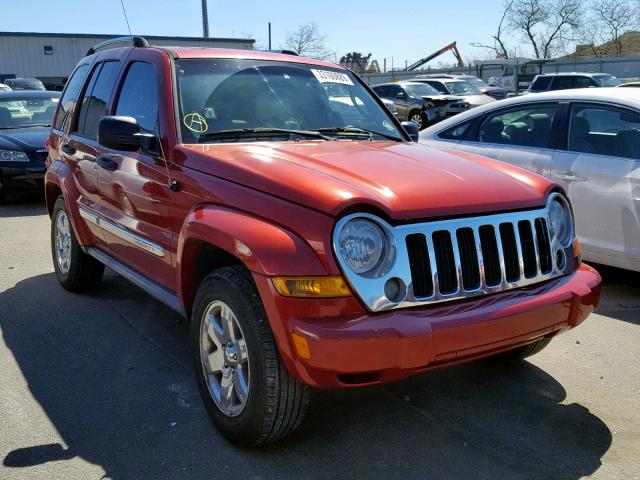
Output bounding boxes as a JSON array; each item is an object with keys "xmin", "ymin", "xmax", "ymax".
[{"xmin": 338, "ymin": 218, "xmax": 387, "ymax": 275}]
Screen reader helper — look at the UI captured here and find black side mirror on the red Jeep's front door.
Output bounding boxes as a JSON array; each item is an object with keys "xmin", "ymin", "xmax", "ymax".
[{"xmin": 98, "ymin": 116, "xmax": 157, "ymax": 152}]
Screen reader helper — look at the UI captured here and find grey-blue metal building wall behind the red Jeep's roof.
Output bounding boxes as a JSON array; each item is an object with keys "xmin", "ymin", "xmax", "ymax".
[{"xmin": 0, "ymin": 34, "xmax": 252, "ymax": 77}]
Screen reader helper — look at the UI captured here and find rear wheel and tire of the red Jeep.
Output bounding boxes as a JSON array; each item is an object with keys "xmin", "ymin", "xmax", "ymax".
[{"xmin": 51, "ymin": 195, "xmax": 104, "ymax": 292}]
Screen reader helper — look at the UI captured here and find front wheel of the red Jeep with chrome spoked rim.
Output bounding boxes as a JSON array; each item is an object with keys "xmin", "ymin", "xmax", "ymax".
[{"xmin": 191, "ymin": 267, "xmax": 309, "ymax": 447}]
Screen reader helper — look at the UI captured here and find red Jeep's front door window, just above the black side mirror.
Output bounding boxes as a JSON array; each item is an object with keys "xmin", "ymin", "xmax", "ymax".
[{"xmin": 116, "ymin": 62, "xmax": 158, "ymax": 133}]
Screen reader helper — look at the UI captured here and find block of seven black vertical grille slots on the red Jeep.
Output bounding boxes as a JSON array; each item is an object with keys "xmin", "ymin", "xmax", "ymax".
[{"xmin": 405, "ymin": 217, "xmax": 552, "ymax": 300}]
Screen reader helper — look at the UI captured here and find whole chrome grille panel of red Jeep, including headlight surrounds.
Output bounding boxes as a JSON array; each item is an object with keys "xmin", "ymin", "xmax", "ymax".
[{"xmin": 333, "ymin": 193, "xmax": 574, "ymax": 312}]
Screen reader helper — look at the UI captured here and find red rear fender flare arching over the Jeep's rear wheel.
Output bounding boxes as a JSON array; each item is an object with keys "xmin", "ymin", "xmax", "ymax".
[{"xmin": 44, "ymin": 160, "xmax": 92, "ymax": 246}]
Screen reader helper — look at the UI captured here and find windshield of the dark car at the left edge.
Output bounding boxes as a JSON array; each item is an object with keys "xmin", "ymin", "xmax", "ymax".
[{"xmin": 0, "ymin": 96, "xmax": 58, "ymax": 129}]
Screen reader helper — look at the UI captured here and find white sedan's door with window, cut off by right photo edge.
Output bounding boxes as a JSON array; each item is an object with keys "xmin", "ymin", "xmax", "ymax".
[{"xmin": 551, "ymin": 103, "xmax": 640, "ymax": 269}]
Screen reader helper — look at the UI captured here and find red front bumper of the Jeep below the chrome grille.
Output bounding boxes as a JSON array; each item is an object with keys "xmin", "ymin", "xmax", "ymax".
[{"xmin": 256, "ymin": 265, "xmax": 600, "ymax": 387}]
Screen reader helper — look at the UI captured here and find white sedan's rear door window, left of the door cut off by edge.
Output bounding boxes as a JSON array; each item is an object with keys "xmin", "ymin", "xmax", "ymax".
[{"xmin": 478, "ymin": 104, "xmax": 558, "ymax": 148}]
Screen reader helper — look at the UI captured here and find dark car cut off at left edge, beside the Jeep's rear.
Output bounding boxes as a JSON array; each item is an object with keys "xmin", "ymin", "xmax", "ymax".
[{"xmin": 0, "ymin": 91, "xmax": 60, "ymax": 195}]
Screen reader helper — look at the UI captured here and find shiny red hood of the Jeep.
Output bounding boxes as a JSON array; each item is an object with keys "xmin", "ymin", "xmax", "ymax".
[{"xmin": 175, "ymin": 141, "xmax": 553, "ymax": 221}]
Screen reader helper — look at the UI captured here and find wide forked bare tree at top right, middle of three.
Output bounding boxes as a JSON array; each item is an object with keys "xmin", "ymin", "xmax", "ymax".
[{"xmin": 508, "ymin": 0, "xmax": 584, "ymax": 58}]
